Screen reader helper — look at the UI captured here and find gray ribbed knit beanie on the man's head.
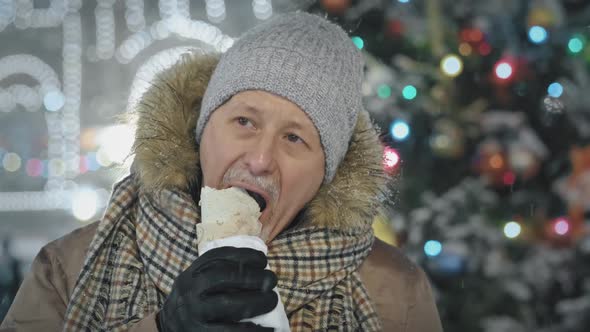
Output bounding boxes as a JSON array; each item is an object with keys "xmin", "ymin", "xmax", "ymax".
[{"xmin": 196, "ymin": 12, "xmax": 363, "ymax": 183}]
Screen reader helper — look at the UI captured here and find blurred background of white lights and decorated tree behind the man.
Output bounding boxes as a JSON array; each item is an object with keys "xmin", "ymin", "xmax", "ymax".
[{"xmin": 0, "ymin": 0, "xmax": 590, "ymax": 332}]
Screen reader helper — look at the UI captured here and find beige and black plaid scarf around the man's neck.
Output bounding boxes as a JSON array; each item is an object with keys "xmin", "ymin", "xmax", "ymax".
[{"xmin": 64, "ymin": 175, "xmax": 381, "ymax": 331}]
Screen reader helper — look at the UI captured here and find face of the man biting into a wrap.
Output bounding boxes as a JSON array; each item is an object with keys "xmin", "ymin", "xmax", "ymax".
[{"xmin": 200, "ymin": 90, "xmax": 325, "ymax": 242}]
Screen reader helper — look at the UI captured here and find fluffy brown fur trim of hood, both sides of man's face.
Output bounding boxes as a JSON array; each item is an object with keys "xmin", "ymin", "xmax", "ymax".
[{"xmin": 132, "ymin": 52, "xmax": 388, "ymax": 229}]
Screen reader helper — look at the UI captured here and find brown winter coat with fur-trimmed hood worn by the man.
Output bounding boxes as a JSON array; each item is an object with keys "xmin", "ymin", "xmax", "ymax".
[{"xmin": 0, "ymin": 55, "xmax": 442, "ymax": 332}]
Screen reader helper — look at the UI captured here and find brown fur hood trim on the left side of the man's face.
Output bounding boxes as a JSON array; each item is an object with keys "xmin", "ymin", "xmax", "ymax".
[{"xmin": 133, "ymin": 53, "xmax": 218, "ymax": 191}]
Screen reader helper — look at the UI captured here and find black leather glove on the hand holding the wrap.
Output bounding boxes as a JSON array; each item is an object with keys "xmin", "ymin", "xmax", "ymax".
[{"xmin": 156, "ymin": 247, "xmax": 278, "ymax": 332}]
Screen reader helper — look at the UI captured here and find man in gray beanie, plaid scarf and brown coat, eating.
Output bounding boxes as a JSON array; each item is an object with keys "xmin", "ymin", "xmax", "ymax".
[{"xmin": 2, "ymin": 13, "xmax": 442, "ymax": 332}]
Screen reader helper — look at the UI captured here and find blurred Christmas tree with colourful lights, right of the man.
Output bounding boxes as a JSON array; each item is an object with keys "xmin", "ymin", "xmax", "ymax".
[{"xmin": 310, "ymin": 0, "xmax": 590, "ymax": 332}]
